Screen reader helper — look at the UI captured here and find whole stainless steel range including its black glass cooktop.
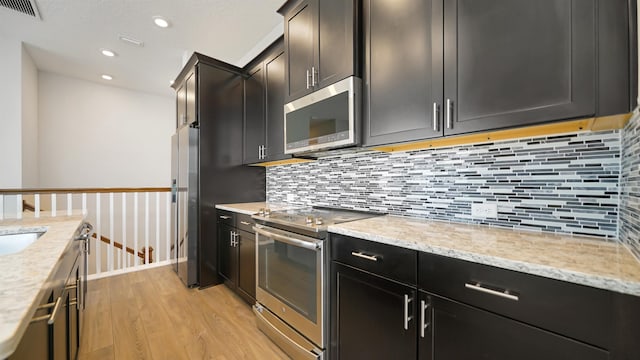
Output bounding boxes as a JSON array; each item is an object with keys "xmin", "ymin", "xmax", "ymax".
[{"xmin": 253, "ymin": 207, "xmax": 380, "ymax": 359}]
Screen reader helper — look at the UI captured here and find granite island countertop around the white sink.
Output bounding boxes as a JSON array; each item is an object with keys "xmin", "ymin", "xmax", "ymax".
[{"xmin": 0, "ymin": 212, "xmax": 84, "ymax": 359}]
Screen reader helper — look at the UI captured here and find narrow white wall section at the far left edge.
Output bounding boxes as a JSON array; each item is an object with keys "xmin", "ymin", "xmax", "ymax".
[{"xmin": 0, "ymin": 36, "xmax": 22, "ymax": 188}]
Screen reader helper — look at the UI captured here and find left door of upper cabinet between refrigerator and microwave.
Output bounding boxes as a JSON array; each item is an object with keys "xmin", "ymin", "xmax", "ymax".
[{"xmin": 243, "ymin": 64, "xmax": 265, "ymax": 164}]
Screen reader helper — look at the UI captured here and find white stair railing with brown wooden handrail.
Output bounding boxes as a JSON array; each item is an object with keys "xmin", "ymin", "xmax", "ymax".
[{"xmin": 0, "ymin": 188, "xmax": 172, "ymax": 279}]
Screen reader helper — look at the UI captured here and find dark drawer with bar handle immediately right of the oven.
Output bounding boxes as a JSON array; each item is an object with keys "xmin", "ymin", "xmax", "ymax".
[{"xmin": 331, "ymin": 234, "xmax": 418, "ymax": 285}]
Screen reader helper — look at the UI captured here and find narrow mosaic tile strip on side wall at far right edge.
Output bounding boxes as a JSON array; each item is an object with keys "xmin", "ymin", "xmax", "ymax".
[{"xmin": 620, "ymin": 113, "xmax": 640, "ymax": 259}]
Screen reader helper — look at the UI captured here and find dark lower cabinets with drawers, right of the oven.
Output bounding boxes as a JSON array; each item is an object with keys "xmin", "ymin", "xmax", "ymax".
[{"xmin": 330, "ymin": 234, "xmax": 640, "ymax": 360}]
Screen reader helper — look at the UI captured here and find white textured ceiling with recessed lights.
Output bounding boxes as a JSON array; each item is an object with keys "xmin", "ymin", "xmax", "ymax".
[{"xmin": 0, "ymin": 0, "xmax": 284, "ymax": 95}]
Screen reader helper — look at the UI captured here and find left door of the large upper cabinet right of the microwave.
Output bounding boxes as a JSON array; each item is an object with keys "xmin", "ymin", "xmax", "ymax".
[{"xmin": 364, "ymin": 0, "xmax": 443, "ymax": 145}]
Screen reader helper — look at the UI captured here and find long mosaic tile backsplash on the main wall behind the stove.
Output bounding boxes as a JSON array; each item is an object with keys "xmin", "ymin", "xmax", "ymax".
[{"xmin": 267, "ymin": 131, "xmax": 620, "ymax": 240}]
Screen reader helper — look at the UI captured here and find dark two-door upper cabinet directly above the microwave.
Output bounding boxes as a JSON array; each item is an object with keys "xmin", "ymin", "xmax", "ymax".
[{"xmin": 278, "ymin": 0, "xmax": 361, "ymax": 102}]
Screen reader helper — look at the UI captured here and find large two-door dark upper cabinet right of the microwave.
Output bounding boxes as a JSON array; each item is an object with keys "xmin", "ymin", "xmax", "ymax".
[{"xmin": 363, "ymin": 0, "xmax": 636, "ymax": 146}]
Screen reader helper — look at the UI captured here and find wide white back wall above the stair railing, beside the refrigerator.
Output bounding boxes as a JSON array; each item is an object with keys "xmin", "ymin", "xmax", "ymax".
[{"xmin": 38, "ymin": 72, "xmax": 175, "ymax": 188}]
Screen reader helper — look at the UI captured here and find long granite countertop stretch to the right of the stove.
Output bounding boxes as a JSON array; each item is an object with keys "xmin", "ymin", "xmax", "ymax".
[{"xmin": 329, "ymin": 215, "xmax": 640, "ymax": 296}]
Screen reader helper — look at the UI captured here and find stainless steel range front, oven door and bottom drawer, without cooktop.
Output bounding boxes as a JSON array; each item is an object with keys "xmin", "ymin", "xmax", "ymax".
[{"xmin": 255, "ymin": 225, "xmax": 327, "ymax": 359}]
